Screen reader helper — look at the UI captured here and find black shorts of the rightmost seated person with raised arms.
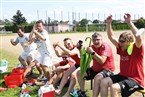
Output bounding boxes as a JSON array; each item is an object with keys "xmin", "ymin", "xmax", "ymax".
[{"xmin": 110, "ymin": 75, "xmax": 143, "ymax": 97}]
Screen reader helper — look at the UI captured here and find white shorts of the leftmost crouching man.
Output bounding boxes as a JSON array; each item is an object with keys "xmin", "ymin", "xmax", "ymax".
[{"xmin": 20, "ymin": 50, "xmax": 39, "ymax": 61}]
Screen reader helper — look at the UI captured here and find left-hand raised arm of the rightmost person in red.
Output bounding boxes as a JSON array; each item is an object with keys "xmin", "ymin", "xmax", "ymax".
[{"xmin": 106, "ymin": 15, "xmax": 118, "ymax": 47}]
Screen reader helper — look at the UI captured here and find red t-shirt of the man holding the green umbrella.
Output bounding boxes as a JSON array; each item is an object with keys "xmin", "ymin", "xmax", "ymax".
[{"xmin": 91, "ymin": 43, "xmax": 115, "ymax": 72}]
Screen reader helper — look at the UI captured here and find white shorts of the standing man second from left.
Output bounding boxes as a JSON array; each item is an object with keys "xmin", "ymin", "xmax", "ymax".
[{"xmin": 37, "ymin": 53, "xmax": 53, "ymax": 67}]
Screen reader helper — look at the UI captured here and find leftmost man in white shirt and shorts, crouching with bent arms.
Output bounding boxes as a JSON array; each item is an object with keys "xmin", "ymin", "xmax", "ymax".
[{"xmin": 10, "ymin": 27, "xmax": 42, "ymax": 76}]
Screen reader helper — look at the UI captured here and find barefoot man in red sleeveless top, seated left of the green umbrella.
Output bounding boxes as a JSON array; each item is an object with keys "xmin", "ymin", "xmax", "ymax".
[{"xmin": 55, "ymin": 38, "xmax": 80, "ymax": 97}]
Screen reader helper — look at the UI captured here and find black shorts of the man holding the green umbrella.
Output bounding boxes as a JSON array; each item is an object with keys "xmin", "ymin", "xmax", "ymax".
[{"xmin": 84, "ymin": 68, "xmax": 114, "ymax": 80}]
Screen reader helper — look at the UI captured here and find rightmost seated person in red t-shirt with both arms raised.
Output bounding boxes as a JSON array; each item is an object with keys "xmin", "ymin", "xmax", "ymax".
[{"xmin": 101, "ymin": 13, "xmax": 144, "ymax": 97}]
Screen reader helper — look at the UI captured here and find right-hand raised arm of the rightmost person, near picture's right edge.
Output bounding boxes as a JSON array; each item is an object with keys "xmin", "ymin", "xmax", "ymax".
[{"xmin": 124, "ymin": 13, "xmax": 143, "ymax": 48}]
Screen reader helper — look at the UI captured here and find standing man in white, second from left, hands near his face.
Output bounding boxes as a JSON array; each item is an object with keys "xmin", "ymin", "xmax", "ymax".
[{"xmin": 30, "ymin": 20, "xmax": 52, "ymax": 81}]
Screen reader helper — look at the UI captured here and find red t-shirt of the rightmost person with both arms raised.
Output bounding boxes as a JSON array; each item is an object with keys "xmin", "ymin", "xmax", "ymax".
[{"xmin": 117, "ymin": 44, "xmax": 144, "ymax": 87}]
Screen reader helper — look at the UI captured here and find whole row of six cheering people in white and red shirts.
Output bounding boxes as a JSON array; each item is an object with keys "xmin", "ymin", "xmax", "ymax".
[{"xmin": 11, "ymin": 13, "xmax": 144, "ymax": 97}]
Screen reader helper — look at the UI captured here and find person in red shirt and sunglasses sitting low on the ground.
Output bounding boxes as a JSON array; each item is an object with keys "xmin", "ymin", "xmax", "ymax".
[{"xmin": 48, "ymin": 43, "xmax": 75, "ymax": 86}]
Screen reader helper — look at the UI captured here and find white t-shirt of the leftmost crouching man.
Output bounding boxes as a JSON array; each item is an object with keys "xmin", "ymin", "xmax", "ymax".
[{"xmin": 16, "ymin": 35, "xmax": 36, "ymax": 52}]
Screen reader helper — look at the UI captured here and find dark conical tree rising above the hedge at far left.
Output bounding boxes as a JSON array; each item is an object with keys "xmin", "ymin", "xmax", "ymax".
[{"xmin": 12, "ymin": 10, "xmax": 27, "ymax": 25}]
